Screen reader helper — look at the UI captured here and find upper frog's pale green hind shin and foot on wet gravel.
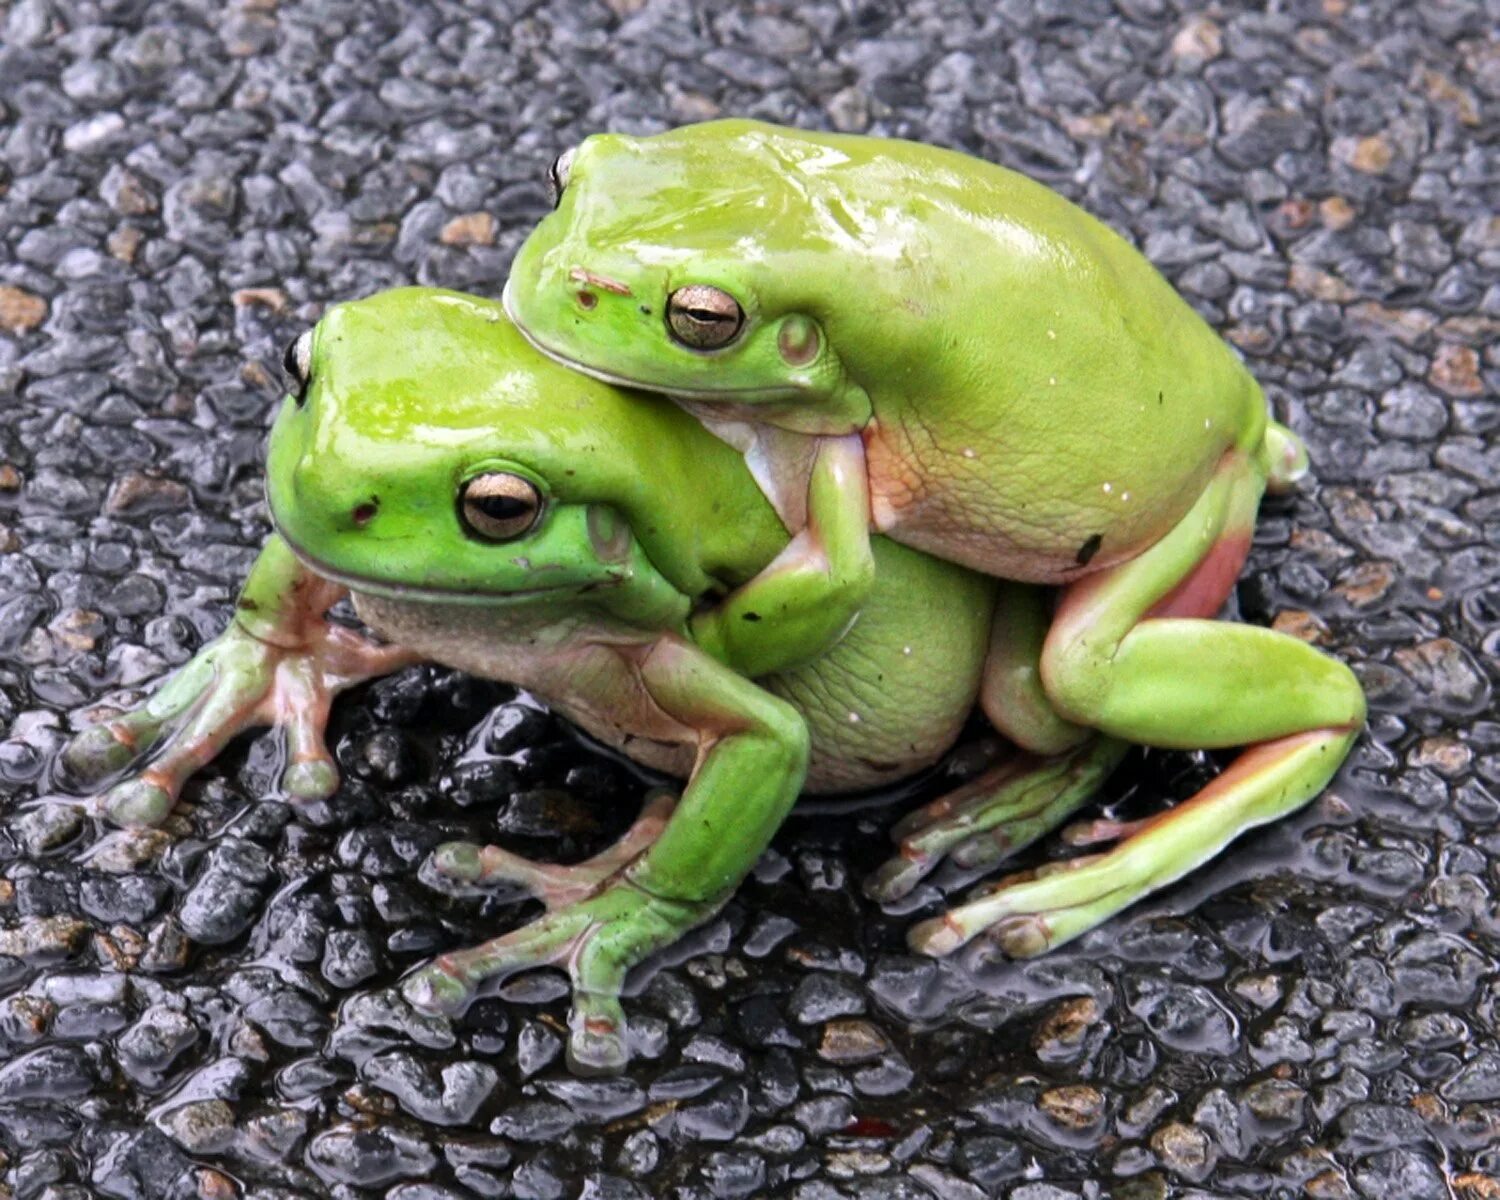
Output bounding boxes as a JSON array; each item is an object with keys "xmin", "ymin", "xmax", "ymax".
[{"xmin": 908, "ymin": 729, "xmax": 1356, "ymax": 959}]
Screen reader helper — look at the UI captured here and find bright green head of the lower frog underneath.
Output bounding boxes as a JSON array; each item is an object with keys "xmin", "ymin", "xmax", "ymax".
[{"xmin": 267, "ymin": 288, "xmax": 686, "ymax": 618}]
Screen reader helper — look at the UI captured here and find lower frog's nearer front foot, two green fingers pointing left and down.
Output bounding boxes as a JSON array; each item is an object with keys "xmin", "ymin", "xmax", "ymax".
[{"xmin": 402, "ymin": 869, "xmax": 728, "ymax": 1074}]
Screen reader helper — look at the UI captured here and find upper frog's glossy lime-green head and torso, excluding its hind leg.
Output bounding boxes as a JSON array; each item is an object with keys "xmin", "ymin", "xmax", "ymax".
[{"xmin": 506, "ymin": 120, "xmax": 1305, "ymax": 684}]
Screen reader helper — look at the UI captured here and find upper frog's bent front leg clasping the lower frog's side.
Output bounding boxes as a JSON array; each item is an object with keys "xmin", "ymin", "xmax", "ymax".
[{"xmin": 692, "ymin": 434, "xmax": 875, "ymax": 678}]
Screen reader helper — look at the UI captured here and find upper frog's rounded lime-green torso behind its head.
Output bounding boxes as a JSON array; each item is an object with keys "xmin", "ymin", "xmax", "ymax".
[{"xmin": 729, "ymin": 126, "xmax": 1266, "ymax": 584}]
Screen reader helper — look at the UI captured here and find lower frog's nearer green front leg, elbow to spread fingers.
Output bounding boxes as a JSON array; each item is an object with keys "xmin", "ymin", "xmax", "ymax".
[{"xmin": 404, "ymin": 636, "xmax": 809, "ymax": 1073}]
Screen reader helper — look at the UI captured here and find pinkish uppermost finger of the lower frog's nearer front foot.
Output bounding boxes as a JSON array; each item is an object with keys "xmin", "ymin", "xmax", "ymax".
[{"xmin": 422, "ymin": 792, "xmax": 677, "ymax": 912}]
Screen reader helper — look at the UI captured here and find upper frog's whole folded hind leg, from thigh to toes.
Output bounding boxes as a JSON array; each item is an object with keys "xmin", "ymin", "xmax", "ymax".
[{"xmin": 911, "ymin": 452, "xmax": 1365, "ymax": 956}]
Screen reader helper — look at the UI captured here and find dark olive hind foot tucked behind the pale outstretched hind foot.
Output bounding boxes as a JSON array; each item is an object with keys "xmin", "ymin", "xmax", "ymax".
[{"xmin": 864, "ymin": 738, "xmax": 1127, "ymax": 903}]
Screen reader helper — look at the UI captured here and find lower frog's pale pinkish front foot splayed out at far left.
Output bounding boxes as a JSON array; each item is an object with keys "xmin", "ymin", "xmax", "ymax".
[{"xmin": 63, "ymin": 536, "xmax": 417, "ymax": 825}]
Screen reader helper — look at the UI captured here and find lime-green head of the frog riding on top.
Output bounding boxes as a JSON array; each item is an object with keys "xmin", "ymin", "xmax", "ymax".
[{"xmin": 504, "ymin": 122, "xmax": 870, "ymax": 432}]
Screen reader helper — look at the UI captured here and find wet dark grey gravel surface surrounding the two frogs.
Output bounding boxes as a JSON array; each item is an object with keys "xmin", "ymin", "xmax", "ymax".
[{"xmin": 0, "ymin": 0, "xmax": 1500, "ymax": 1200}]
